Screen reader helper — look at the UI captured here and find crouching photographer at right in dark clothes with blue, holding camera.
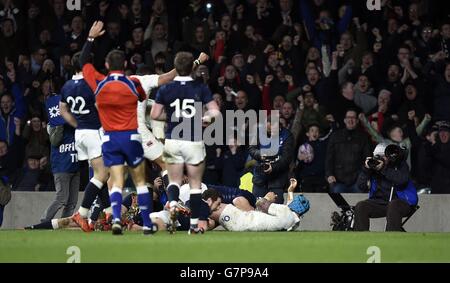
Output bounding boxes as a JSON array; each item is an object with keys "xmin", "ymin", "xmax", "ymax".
[{"xmin": 354, "ymin": 143, "xmax": 418, "ymax": 231}]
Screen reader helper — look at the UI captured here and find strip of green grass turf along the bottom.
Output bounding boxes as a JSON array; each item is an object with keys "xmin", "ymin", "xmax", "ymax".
[{"xmin": 0, "ymin": 230, "xmax": 450, "ymax": 263}]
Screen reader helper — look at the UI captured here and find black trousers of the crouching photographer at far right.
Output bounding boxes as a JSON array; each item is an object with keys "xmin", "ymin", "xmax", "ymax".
[{"xmin": 354, "ymin": 199, "xmax": 412, "ymax": 231}]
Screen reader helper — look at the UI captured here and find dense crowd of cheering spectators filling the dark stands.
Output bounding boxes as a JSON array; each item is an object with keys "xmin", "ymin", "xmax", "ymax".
[{"xmin": 0, "ymin": 0, "xmax": 450, "ymax": 193}]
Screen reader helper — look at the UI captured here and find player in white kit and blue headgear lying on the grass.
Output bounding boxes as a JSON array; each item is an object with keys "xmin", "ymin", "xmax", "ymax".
[{"xmin": 202, "ymin": 179, "xmax": 304, "ymax": 232}]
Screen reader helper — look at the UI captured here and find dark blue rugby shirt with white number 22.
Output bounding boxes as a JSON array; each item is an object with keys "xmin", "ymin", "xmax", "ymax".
[{"xmin": 61, "ymin": 76, "xmax": 101, "ymax": 130}]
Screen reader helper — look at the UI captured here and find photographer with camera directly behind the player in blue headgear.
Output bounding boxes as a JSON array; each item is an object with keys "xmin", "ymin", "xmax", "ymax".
[{"xmin": 249, "ymin": 117, "xmax": 294, "ymax": 204}]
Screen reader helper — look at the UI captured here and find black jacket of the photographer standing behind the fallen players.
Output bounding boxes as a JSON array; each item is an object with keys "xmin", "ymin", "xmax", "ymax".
[{"xmin": 249, "ymin": 129, "xmax": 295, "ymax": 189}]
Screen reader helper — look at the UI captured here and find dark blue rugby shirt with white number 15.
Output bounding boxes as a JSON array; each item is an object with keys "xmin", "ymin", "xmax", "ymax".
[{"xmin": 155, "ymin": 77, "xmax": 213, "ymax": 141}]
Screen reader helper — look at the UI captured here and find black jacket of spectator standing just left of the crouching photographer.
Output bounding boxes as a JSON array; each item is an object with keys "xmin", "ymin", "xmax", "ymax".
[{"xmin": 325, "ymin": 129, "xmax": 371, "ymax": 185}]
